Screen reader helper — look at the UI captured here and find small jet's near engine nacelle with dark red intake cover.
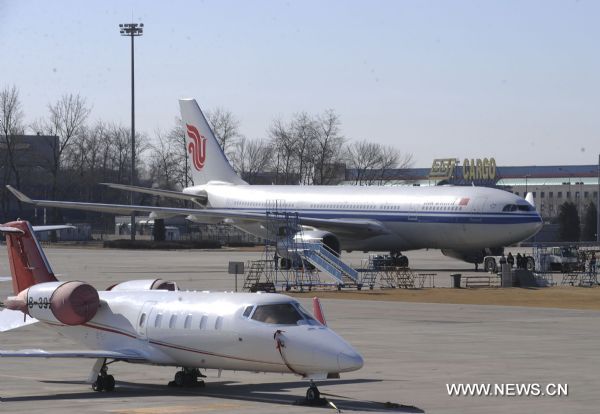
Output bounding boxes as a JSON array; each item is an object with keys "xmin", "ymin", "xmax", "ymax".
[{"xmin": 18, "ymin": 281, "xmax": 100, "ymax": 325}]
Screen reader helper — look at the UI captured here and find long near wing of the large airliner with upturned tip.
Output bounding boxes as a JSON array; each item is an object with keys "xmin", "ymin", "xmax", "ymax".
[{"xmin": 6, "ymin": 185, "xmax": 389, "ymax": 237}]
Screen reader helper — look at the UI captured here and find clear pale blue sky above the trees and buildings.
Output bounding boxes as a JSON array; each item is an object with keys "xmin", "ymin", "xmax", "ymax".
[{"xmin": 0, "ymin": 0, "xmax": 600, "ymax": 167}]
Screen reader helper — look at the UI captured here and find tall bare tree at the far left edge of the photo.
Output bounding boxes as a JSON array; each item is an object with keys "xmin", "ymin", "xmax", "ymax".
[{"xmin": 0, "ymin": 85, "xmax": 24, "ymax": 216}]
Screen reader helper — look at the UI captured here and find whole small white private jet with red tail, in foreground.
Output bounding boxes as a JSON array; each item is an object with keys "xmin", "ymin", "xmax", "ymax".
[{"xmin": 0, "ymin": 221, "xmax": 363, "ymax": 402}]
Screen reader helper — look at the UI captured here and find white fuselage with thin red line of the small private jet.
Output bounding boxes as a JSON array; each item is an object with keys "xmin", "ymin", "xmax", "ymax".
[{"xmin": 52, "ymin": 289, "xmax": 362, "ymax": 378}]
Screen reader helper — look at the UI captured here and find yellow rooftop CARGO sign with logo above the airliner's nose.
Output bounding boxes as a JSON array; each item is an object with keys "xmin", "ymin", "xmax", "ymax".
[{"xmin": 429, "ymin": 158, "xmax": 497, "ymax": 181}]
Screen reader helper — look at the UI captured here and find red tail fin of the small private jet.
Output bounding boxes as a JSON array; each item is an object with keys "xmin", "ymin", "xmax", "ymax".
[{"xmin": 0, "ymin": 220, "xmax": 57, "ymax": 295}]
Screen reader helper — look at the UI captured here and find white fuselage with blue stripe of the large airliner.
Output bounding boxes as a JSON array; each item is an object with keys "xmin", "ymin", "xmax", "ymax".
[{"xmin": 184, "ymin": 184, "xmax": 542, "ymax": 251}]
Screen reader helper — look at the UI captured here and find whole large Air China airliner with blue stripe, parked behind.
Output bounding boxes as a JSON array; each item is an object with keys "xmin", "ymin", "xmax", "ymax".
[{"xmin": 5, "ymin": 99, "xmax": 542, "ymax": 265}]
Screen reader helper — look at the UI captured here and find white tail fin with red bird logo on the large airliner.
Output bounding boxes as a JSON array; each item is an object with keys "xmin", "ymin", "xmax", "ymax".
[{"xmin": 179, "ymin": 99, "xmax": 246, "ymax": 185}]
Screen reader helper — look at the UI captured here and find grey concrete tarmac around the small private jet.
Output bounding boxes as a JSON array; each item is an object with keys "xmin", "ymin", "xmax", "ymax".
[{"xmin": 0, "ymin": 246, "xmax": 600, "ymax": 414}]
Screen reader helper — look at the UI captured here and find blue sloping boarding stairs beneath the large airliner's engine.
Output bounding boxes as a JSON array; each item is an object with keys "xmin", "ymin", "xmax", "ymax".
[{"xmin": 298, "ymin": 243, "xmax": 360, "ymax": 287}]
